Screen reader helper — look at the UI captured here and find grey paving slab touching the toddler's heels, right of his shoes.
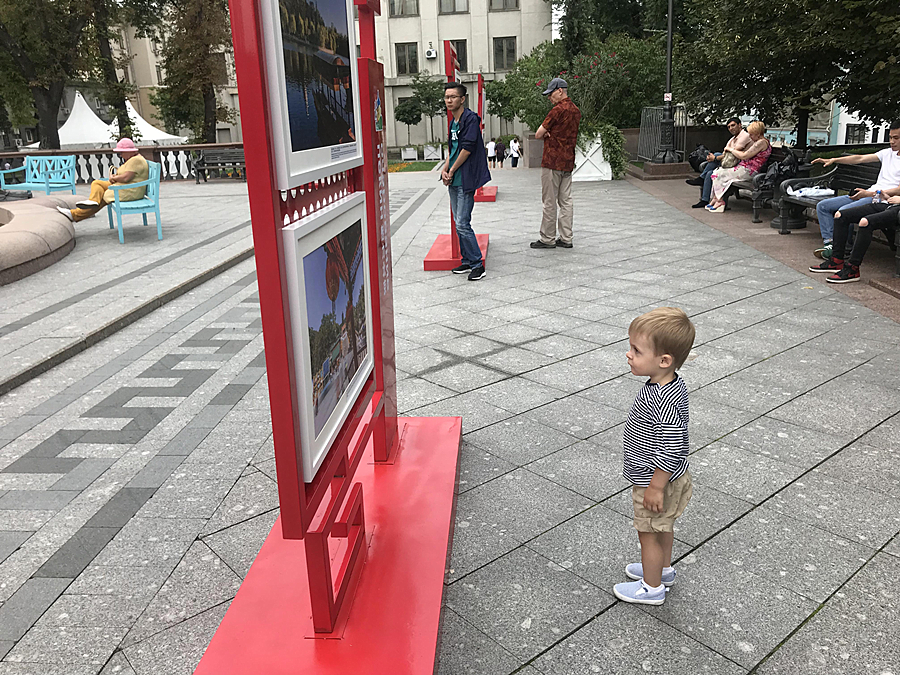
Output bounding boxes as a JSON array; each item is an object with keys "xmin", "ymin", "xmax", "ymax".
[{"xmin": 646, "ymin": 549, "xmax": 818, "ymax": 668}]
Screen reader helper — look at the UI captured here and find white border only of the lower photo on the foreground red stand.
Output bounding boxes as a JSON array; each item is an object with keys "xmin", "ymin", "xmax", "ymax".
[{"xmin": 282, "ymin": 192, "xmax": 375, "ymax": 483}]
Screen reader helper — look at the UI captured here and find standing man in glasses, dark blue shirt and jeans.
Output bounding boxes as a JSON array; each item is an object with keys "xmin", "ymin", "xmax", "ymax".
[{"xmin": 441, "ymin": 82, "xmax": 491, "ymax": 281}]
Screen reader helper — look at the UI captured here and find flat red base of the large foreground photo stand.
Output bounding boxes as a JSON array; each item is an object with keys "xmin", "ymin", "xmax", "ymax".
[{"xmin": 194, "ymin": 417, "xmax": 462, "ymax": 675}]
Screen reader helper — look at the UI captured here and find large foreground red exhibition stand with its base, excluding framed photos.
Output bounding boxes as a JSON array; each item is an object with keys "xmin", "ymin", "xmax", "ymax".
[{"xmin": 195, "ymin": 0, "xmax": 464, "ymax": 675}]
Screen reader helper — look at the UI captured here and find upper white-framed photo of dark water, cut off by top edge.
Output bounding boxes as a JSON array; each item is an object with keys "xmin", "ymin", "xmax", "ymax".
[{"xmin": 261, "ymin": 0, "xmax": 363, "ymax": 190}]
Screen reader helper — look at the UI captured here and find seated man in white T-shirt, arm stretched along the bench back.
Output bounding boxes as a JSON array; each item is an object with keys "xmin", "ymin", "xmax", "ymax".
[{"xmin": 813, "ymin": 120, "xmax": 900, "ymax": 259}]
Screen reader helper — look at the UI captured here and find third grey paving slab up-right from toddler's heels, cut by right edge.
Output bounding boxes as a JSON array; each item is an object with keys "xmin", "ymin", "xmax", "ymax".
[{"xmin": 768, "ymin": 471, "xmax": 900, "ymax": 548}]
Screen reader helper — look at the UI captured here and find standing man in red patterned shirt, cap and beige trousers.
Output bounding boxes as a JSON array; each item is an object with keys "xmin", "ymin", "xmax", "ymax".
[{"xmin": 531, "ymin": 77, "xmax": 581, "ymax": 248}]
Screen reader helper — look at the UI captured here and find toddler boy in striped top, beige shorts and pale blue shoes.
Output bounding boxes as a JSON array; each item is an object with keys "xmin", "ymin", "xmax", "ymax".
[{"xmin": 613, "ymin": 307, "xmax": 694, "ymax": 605}]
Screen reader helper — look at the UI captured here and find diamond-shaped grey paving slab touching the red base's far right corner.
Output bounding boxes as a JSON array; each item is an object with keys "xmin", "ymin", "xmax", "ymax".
[{"xmin": 465, "ymin": 416, "xmax": 578, "ymax": 466}]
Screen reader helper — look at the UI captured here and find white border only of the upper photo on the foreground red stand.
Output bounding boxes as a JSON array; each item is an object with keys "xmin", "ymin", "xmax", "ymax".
[{"xmin": 260, "ymin": 0, "xmax": 364, "ymax": 191}]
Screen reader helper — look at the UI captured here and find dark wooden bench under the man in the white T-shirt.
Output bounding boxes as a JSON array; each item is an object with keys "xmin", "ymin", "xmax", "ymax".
[{"xmin": 772, "ymin": 162, "xmax": 881, "ymax": 234}]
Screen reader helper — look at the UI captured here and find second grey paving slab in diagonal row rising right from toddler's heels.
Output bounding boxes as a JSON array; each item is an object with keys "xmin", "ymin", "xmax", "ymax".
[{"xmin": 704, "ymin": 506, "xmax": 872, "ymax": 602}]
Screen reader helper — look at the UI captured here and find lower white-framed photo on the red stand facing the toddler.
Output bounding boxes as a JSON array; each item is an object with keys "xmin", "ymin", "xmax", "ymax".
[{"xmin": 282, "ymin": 193, "xmax": 374, "ymax": 482}]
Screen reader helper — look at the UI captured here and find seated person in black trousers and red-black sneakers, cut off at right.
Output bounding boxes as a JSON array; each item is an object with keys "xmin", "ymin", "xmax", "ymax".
[{"xmin": 809, "ymin": 186, "xmax": 900, "ymax": 284}]
